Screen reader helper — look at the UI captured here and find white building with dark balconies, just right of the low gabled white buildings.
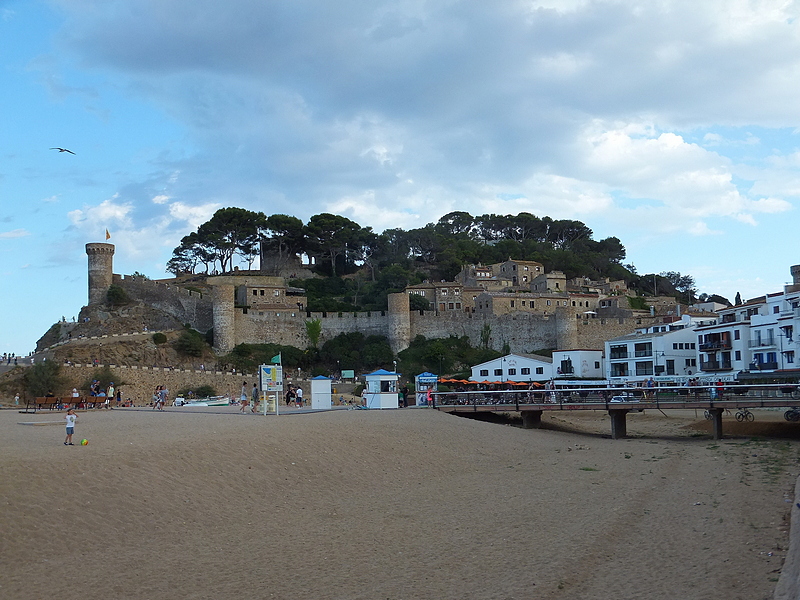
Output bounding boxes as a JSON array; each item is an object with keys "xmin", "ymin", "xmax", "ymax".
[{"xmin": 605, "ymin": 315, "xmax": 716, "ymax": 383}]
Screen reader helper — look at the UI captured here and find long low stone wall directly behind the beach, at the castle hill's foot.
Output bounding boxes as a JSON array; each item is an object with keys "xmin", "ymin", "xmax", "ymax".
[{"xmin": 62, "ymin": 364, "xmax": 257, "ymax": 406}]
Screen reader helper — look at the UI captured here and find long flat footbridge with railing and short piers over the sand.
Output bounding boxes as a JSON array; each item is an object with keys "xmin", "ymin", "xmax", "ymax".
[{"xmin": 432, "ymin": 384, "xmax": 800, "ymax": 440}]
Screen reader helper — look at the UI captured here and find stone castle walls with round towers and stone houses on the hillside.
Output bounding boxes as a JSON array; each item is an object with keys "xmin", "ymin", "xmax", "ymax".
[{"xmin": 86, "ymin": 243, "xmax": 692, "ymax": 353}]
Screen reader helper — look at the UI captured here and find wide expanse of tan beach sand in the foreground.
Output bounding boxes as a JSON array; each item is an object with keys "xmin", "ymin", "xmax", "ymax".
[{"xmin": 0, "ymin": 408, "xmax": 800, "ymax": 600}]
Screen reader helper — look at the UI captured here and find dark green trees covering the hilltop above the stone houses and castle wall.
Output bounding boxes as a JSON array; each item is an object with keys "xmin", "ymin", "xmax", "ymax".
[{"xmin": 168, "ymin": 208, "xmax": 696, "ymax": 311}]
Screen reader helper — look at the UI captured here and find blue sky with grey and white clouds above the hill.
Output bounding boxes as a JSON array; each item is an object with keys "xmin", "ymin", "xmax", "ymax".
[{"xmin": 0, "ymin": 0, "xmax": 800, "ymax": 354}]
